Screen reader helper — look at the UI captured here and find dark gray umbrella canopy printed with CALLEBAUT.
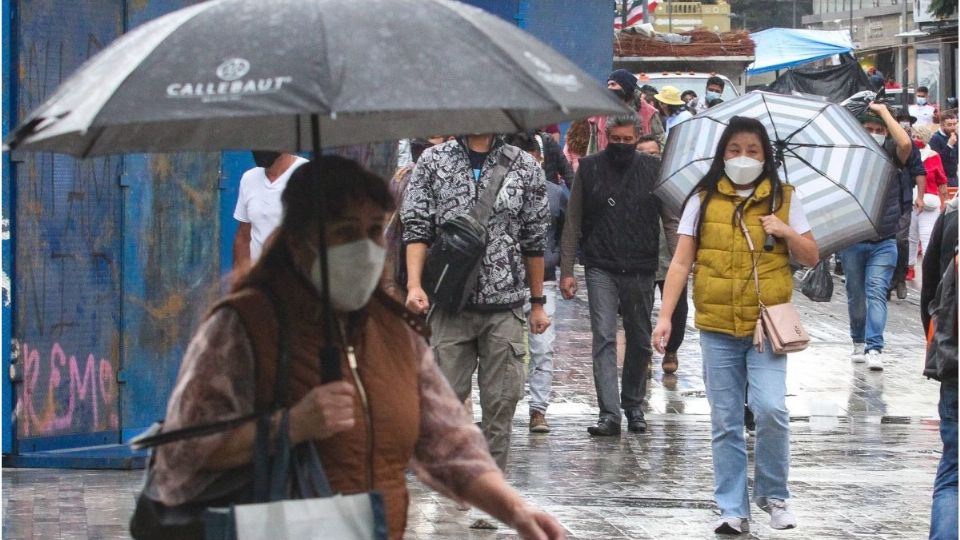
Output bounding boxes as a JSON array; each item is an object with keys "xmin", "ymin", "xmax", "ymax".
[{"xmin": 8, "ymin": 0, "xmax": 625, "ymax": 157}]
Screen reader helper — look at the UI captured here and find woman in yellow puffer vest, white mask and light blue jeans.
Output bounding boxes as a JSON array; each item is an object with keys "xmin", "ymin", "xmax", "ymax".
[{"xmin": 653, "ymin": 117, "xmax": 818, "ymax": 534}]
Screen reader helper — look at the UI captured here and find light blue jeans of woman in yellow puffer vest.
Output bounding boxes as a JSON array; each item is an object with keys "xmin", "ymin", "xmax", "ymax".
[{"xmin": 700, "ymin": 330, "xmax": 790, "ymax": 518}]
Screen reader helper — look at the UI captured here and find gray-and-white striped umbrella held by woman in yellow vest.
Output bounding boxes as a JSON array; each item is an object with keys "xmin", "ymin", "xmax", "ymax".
[{"xmin": 656, "ymin": 91, "xmax": 897, "ymax": 255}]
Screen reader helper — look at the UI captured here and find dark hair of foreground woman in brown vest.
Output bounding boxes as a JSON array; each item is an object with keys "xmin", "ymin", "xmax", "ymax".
[{"xmin": 231, "ymin": 156, "xmax": 393, "ymax": 291}]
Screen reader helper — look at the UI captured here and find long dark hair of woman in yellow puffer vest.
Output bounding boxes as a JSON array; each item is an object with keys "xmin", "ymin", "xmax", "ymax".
[{"xmin": 683, "ymin": 116, "xmax": 783, "ymax": 239}]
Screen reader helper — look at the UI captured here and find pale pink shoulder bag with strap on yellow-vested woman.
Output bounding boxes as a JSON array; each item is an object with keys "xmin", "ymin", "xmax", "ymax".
[{"xmin": 739, "ymin": 215, "xmax": 810, "ymax": 354}]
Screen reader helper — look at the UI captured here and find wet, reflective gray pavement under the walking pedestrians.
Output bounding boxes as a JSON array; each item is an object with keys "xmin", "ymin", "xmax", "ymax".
[{"xmin": 3, "ymin": 268, "xmax": 941, "ymax": 540}]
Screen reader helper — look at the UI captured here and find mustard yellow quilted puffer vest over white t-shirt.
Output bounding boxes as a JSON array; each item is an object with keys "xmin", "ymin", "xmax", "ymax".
[{"xmin": 693, "ymin": 177, "xmax": 793, "ymax": 337}]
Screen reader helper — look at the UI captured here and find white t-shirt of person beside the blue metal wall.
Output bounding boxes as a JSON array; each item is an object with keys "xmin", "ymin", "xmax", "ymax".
[{"xmin": 233, "ymin": 157, "xmax": 307, "ymax": 263}]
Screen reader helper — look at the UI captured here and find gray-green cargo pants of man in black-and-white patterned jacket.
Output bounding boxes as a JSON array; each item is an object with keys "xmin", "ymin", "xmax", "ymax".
[{"xmin": 430, "ymin": 307, "xmax": 526, "ymax": 472}]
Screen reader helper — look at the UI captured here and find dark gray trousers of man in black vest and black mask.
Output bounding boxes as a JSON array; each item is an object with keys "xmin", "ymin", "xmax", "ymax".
[{"xmin": 585, "ymin": 268, "xmax": 654, "ymax": 424}]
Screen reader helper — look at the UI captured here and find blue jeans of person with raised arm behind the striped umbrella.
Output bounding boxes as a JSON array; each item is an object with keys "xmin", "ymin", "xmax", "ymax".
[{"xmin": 839, "ymin": 238, "xmax": 897, "ymax": 351}]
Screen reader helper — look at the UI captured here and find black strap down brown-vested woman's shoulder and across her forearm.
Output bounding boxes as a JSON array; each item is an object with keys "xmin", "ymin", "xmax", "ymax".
[{"xmin": 129, "ymin": 289, "xmax": 290, "ymax": 450}]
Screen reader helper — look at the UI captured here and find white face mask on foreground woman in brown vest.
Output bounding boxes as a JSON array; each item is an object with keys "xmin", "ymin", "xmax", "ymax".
[{"xmin": 310, "ymin": 239, "xmax": 387, "ymax": 311}]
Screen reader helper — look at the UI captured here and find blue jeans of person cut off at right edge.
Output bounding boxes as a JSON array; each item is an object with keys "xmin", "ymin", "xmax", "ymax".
[{"xmin": 930, "ymin": 381, "xmax": 957, "ymax": 540}]
